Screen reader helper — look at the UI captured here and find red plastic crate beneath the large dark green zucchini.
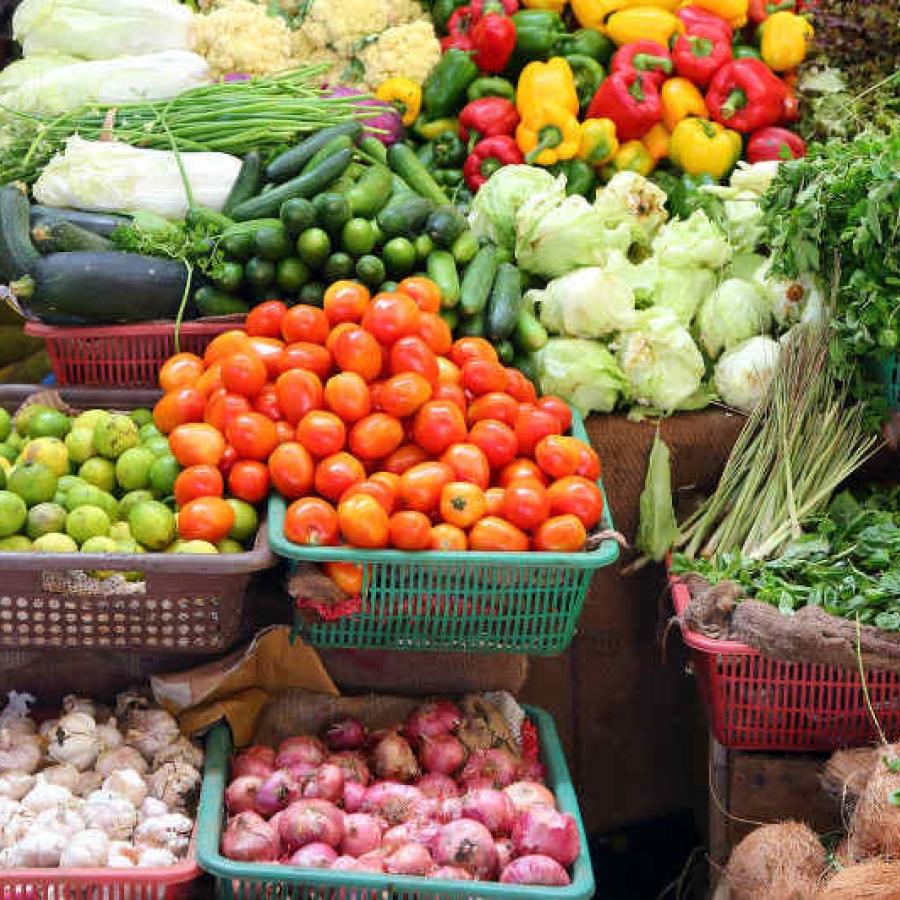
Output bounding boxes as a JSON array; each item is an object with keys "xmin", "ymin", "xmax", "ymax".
[{"xmin": 25, "ymin": 320, "xmax": 241, "ymax": 388}]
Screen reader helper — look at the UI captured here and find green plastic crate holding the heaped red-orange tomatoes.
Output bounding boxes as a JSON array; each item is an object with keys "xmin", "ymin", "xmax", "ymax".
[{"xmin": 268, "ymin": 411, "xmax": 619, "ymax": 656}]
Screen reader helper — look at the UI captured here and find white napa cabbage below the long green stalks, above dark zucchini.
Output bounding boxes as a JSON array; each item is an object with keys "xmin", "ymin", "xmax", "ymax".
[{"xmin": 34, "ymin": 136, "xmax": 241, "ymax": 219}]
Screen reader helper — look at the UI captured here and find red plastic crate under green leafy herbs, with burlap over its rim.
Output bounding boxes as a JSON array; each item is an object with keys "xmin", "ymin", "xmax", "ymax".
[{"xmin": 670, "ymin": 577, "xmax": 900, "ymax": 751}]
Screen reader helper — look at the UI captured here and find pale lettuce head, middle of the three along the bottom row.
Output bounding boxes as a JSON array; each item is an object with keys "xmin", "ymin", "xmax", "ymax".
[{"xmin": 617, "ymin": 309, "xmax": 704, "ymax": 410}]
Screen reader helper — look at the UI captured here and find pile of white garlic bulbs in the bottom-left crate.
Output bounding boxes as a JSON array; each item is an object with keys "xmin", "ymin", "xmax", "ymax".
[{"xmin": 0, "ymin": 692, "xmax": 203, "ymax": 869}]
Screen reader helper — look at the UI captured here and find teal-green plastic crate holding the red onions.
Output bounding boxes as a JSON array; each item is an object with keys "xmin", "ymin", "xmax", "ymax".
[{"xmin": 196, "ymin": 706, "xmax": 594, "ymax": 900}]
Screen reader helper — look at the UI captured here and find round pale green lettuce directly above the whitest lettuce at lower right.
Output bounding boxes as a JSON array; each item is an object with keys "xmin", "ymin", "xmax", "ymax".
[{"xmin": 697, "ymin": 278, "xmax": 772, "ymax": 359}]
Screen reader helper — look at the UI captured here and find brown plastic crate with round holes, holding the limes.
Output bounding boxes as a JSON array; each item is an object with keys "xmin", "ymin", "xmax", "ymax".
[{"xmin": 0, "ymin": 385, "xmax": 274, "ymax": 654}]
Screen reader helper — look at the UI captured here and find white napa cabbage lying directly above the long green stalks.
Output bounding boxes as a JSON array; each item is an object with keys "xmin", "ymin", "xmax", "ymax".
[{"xmin": 3, "ymin": 50, "xmax": 213, "ymax": 116}]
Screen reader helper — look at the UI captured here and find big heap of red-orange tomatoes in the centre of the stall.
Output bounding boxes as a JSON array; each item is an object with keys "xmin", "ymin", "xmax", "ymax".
[{"xmin": 154, "ymin": 277, "xmax": 603, "ymax": 564}]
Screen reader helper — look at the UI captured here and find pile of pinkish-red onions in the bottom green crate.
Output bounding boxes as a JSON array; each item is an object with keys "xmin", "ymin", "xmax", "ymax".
[{"xmin": 222, "ymin": 700, "xmax": 580, "ymax": 887}]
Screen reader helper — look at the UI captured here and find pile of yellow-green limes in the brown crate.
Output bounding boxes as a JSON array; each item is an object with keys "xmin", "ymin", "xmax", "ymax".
[{"xmin": 0, "ymin": 403, "xmax": 257, "ymax": 560}]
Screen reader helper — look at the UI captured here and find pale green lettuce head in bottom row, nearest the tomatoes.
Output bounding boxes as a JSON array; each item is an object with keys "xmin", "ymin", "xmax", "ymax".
[{"xmin": 537, "ymin": 338, "xmax": 628, "ymax": 416}]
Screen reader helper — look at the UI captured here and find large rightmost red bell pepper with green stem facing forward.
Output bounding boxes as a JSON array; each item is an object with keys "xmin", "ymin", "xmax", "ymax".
[{"xmin": 706, "ymin": 58, "xmax": 788, "ymax": 134}]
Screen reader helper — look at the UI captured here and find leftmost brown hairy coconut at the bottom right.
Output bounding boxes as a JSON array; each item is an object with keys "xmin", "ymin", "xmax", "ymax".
[{"xmin": 725, "ymin": 822, "xmax": 825, "ymax": 900}]
